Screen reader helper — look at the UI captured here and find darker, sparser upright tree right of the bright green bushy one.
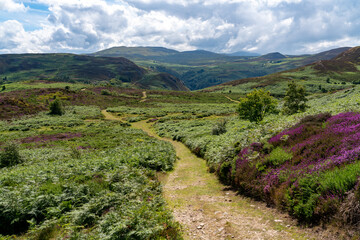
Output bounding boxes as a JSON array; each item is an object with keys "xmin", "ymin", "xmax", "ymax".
[{"xmin": 283, "ymin": 82, "xmax": 308, "ymax": 115}]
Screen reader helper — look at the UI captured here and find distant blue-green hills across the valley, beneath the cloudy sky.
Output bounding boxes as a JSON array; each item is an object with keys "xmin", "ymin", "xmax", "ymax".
[{"xmin": 90, "ymin": 47, "xmax": 347, "ymax": 90}]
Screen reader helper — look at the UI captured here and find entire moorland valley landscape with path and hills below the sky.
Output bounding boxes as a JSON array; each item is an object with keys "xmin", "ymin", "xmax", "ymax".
[{"xmin": 0, "ymin": 47, "xmax": 360, "ymax": 240}]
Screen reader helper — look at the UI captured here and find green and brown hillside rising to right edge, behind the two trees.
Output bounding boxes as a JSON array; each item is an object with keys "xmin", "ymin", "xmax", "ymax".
[{"xmin": 203, "ymin": 47, "xmax": 360, "ymax": 96}]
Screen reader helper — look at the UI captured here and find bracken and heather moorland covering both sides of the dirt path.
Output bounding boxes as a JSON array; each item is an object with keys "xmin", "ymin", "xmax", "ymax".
[{"xmin": 0, "ymin": 45, "xmax": 360, "ymax": 239}]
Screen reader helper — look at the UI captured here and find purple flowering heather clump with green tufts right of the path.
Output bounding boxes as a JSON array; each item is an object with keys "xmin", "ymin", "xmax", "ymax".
[{"xmin": 228, "ymin": 112, "xmax": 360, "ymax": 221}]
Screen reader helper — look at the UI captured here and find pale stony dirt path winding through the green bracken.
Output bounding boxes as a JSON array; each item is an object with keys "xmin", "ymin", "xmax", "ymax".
[{"xmin": 101, "ymin": 111, "xmax": 330, "ymax": 240}]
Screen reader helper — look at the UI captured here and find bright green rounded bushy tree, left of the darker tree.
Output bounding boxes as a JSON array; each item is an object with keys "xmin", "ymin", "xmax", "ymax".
[{"xmin": 237, "ymin": 89, "xmax": 277, "ymax": 122}]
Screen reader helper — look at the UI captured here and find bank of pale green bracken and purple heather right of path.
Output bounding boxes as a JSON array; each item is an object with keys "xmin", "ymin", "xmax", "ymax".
[{"xmin": 155, "ymin": 88, "xmax": 360, "ymax": 224}]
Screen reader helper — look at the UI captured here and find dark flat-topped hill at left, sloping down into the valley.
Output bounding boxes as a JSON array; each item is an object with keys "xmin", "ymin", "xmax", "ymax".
[{"xmin": 0, "ymin": 54, "xmax": 188, "ymax": 91}]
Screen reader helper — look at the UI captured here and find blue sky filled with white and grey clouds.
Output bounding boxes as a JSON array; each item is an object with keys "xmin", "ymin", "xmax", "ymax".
[{"xmin": 0, "ymin": 0, "xmax": 360, "ymax": 54}]
